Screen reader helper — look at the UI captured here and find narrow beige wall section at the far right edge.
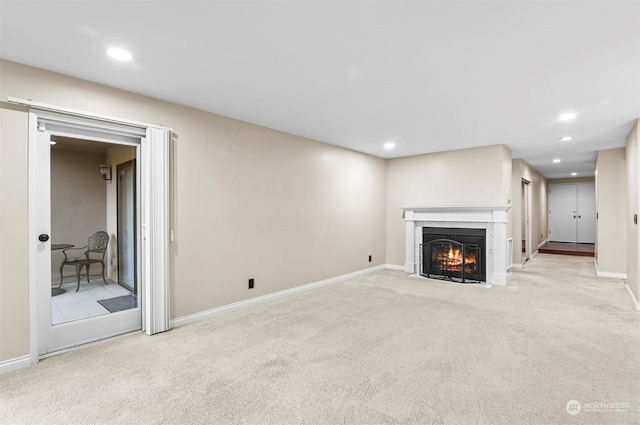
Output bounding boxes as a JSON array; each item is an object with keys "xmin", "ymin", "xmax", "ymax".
[{"xmin": 625, "ymin": 121, "xmax": 640, "ymax": 301}]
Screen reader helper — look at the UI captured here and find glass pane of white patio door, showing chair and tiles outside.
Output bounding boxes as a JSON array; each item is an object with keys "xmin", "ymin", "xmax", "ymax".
[{"xmin": 50, "ymin": 135, "xmax": 138, "ymax": 325}]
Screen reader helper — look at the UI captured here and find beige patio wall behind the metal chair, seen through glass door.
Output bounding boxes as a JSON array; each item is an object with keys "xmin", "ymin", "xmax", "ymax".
[{"xmin": 51, "ymin": 144, "xmax": 106, "ymax": 276}]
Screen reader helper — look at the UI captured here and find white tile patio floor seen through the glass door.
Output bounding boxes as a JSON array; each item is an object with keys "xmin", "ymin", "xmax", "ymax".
[{"xmin": 51, "ymin": 277, "xmax": 131, "ymax": 325}]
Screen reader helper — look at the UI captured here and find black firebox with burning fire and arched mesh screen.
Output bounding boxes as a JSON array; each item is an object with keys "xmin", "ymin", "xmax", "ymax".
[{"xmin": 419, "ymin": 227, "xmax": 486, "ymax": 283}]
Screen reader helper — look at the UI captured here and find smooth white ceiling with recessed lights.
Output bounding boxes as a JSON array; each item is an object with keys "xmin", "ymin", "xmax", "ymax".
[{"xmin": 0, "ymin": 0, "xmax": 640, "ymax": 178}]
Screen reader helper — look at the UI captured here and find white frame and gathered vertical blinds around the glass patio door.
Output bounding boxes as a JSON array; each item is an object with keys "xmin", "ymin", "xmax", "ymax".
[{"xmin": 13, "ymin": 97, "xmax": 171, "ymax": 364}]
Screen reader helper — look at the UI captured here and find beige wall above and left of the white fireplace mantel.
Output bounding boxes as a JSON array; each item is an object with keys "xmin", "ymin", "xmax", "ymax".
[{"xmin": 387, "ymin": 145, "xmax": 511, "ymax": 265}]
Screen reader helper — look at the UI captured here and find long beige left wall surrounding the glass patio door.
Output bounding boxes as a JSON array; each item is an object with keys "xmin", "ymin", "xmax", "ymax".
[{"xmin": 0, "ymin": 61, "xmax": 386, "ymax": 361}]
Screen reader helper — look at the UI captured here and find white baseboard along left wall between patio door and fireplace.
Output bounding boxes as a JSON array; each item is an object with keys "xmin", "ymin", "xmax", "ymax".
[{"xmin": 171, "ymin": 264, "xmax": 387, "ymax": 328}]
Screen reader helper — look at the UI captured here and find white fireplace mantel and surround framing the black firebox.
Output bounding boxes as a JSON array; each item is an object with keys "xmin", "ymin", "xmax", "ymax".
[{"xmin": 403, "ymin": 205, "xmax": 511, "ymax": 285}]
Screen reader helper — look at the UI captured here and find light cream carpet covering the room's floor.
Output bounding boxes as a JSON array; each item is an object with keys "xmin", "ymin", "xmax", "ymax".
[{"xmin": 0, "ymin": 254, "xmax": 640, "ymax": 425}]
